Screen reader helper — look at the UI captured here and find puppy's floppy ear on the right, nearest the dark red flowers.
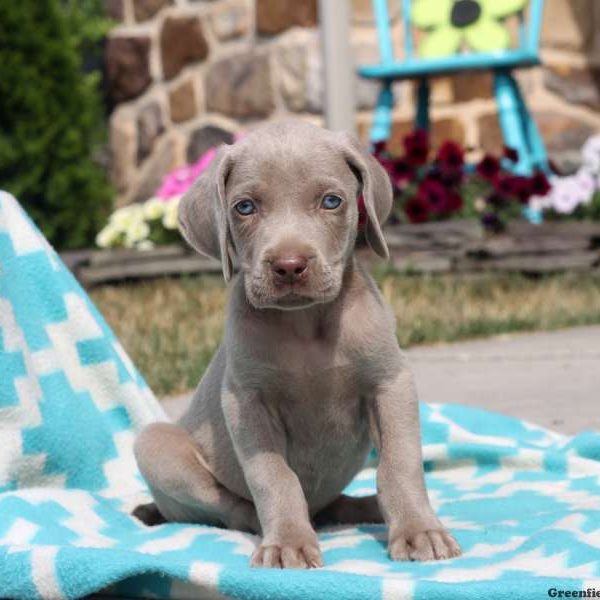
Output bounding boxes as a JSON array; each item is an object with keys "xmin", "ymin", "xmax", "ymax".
[{"xmin": 338, "ymin": 132, "xmax": 393, "ymax": 259}]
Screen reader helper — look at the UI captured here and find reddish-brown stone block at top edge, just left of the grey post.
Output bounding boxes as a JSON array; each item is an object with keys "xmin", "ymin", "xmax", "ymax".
[{"xmin": 256, "ymin": 0, "xmax": 318, "ymax": 35}]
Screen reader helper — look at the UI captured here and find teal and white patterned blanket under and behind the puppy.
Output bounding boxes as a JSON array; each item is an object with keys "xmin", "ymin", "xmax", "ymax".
[{"xmin": 0, "ymin": 193, "xmax": 600, "ymax": 600}]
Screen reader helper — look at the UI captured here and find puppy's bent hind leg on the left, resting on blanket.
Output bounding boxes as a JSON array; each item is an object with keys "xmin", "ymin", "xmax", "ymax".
[{"xmin": 134, "ymin": 423, "xmax": 259, "ymax": 531}]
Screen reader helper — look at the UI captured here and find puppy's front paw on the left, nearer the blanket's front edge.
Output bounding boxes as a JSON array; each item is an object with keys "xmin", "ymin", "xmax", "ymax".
[{"xmin": 250, "ymin": 528, "xmax": 323, "ymax": 569}]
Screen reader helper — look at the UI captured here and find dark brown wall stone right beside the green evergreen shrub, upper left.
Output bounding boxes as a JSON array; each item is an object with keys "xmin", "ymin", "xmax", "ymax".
[{"xmin": 105, "ymin": 36, "xmax": 152, "ymax": 102}]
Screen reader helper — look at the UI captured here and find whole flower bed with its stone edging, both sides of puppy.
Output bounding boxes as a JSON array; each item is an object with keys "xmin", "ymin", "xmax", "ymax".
[{"xmin": 79, "ymin": 131, "xmax": 600, "ymax": 285}]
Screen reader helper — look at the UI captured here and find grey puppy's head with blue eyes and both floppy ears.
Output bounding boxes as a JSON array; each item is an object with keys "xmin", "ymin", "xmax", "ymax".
[{"xmin": 179, "ymin": 122, "xmax": 392, "ymax": 310}]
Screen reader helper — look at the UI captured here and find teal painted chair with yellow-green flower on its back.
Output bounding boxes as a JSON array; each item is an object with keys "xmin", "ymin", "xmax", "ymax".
[{"xmin": 358, "ymin": 0, "xmax": 548, "ymax": 175}]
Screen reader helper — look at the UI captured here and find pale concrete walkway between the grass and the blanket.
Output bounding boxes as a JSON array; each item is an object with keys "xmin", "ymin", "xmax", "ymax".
[{"xmin": 164, "ymin": 327, "xmax": 600, "ymax": 434}]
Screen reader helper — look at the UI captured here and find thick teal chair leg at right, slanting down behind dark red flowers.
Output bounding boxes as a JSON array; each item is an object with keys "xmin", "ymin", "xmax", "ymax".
[{"xmin": 494, "ymin": 71, "xmax": 532, "ymax": 175}]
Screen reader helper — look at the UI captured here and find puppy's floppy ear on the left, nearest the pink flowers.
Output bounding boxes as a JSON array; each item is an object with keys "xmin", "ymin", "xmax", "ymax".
[{"xmin": 178, "ymin": 146, "xmax": 233, "ymax": 281}]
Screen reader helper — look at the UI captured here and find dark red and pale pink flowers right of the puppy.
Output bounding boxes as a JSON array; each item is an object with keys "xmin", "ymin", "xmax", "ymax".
[{"xmin": 374, "ymin": 131, "xmax": 600, "ymax": 233}]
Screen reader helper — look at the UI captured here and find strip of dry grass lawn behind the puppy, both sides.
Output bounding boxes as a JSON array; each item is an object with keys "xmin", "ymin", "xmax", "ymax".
[{"xmin": 91, "ymin": 273, "xmax": 600, "ymax": 396}]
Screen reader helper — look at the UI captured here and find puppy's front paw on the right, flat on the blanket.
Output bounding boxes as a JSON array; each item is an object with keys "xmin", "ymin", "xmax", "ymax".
[{"xmin": 388, "ymin": 528, "xmax": 462, "ymax": 560}]
